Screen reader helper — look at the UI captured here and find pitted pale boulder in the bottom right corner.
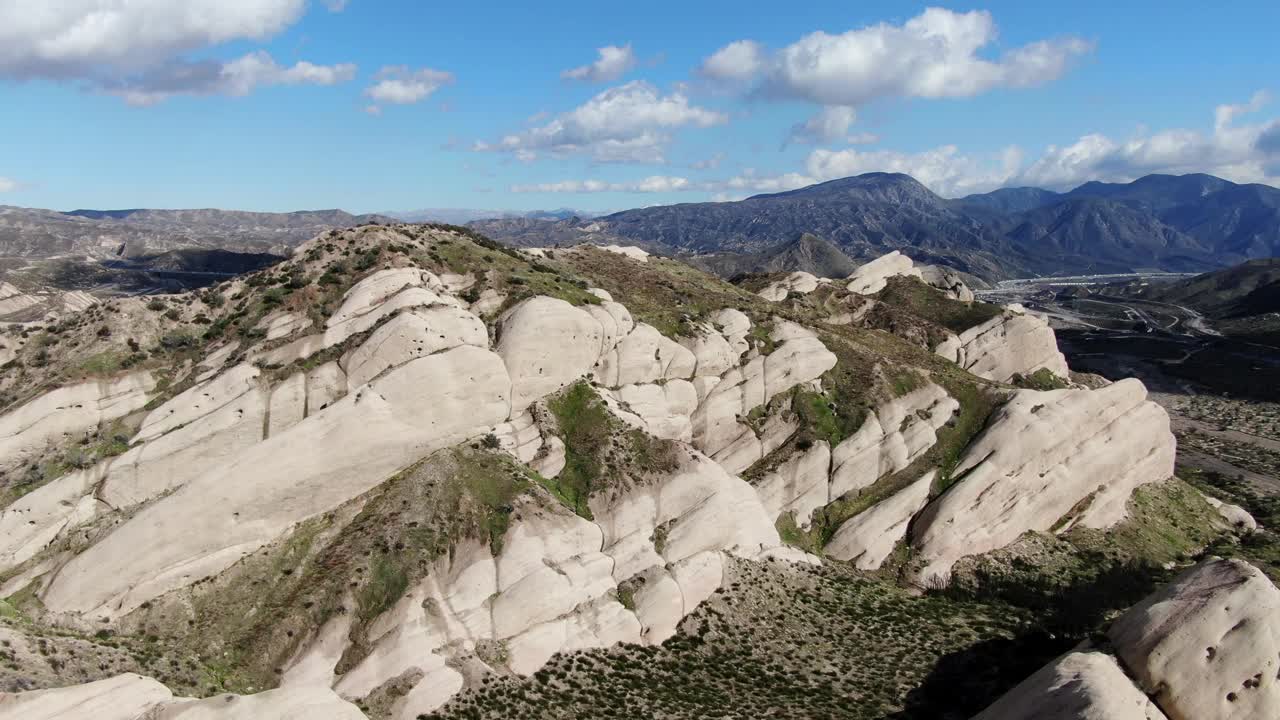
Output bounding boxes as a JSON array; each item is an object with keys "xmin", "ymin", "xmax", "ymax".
[{"xmin": 1107, "ymin": 560, "xmax": 1280, "ymax": 720}]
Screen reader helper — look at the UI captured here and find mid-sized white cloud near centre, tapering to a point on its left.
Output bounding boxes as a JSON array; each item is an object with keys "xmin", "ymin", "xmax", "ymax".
[{"xmin": 474, "ymin": 81, "xmax": 728, "ymax": 163}]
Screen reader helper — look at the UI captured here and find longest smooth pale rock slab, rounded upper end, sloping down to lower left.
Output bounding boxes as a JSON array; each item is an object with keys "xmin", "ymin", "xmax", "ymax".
[{"xmin": 42, "ymin": 346, "xmax": 511, "ymax": 618}]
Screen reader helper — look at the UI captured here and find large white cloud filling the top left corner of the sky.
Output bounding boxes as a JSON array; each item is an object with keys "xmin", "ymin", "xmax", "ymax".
[{"xmin": 0, "ymin": 0, "xmax": 355, "ymax": 105}]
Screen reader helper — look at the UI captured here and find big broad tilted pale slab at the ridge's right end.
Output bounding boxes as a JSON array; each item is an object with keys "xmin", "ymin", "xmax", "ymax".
[{"xmin": 913, "ymin": 379, "xmax": 1175, "ymax": 585}]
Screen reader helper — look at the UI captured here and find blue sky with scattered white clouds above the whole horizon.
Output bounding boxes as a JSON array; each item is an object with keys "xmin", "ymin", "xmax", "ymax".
[{"xmin": 0, "ymin": 0, "xmax": 1280, "ymax": 211}]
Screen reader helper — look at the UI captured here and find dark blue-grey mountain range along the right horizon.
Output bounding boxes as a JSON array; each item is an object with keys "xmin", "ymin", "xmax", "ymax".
[{"xmin": 471, "ymin": 173, "xmax": 1280, "ymax": 279}]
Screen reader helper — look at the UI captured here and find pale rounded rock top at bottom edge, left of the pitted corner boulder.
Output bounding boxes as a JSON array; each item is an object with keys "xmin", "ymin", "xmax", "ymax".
[{"xmin": 973, "ymin": 652, "xmax": 1166, "ymax": 720}]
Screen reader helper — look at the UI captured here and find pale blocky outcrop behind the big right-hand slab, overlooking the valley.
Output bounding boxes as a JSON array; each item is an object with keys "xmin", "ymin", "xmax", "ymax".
[{"xmin": 934, "ymin": 309, "xmax": 1070, "ymax": 383}]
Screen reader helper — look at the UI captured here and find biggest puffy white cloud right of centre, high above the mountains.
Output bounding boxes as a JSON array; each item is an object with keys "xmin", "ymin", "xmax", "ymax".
[{"xmin": 700, "ymin": 8, "xmax": 1092, "ymax": 116}]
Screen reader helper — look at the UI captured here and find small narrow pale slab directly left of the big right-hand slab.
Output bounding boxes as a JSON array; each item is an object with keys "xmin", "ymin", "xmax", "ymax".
[{"xmin": 823, "ymin": 470, "xmax": 937, "ymax": 570}]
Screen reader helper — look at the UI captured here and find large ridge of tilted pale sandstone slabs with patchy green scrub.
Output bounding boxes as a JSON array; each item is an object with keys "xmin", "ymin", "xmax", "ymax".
[{"xmin": 0, "ymin": 227, "xmax": 1244, "ymax": 717}]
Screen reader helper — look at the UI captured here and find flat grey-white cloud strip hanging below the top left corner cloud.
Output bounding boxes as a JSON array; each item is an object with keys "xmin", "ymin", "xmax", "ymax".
[{"xmin": 99, "ymin": 50, "xmax": 356, "ymax": 105}]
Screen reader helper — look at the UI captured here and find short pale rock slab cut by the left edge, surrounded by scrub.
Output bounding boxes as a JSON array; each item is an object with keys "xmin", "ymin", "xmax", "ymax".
[{"xmin": 0, "ymin": 372, "xmax": 155, "ymax": 471}]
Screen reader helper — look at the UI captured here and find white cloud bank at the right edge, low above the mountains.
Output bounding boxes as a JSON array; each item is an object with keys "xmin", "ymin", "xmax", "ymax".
[{"xmin": 1018, "ymin": 92, "xmax": 1280, "ymax": 190}]
